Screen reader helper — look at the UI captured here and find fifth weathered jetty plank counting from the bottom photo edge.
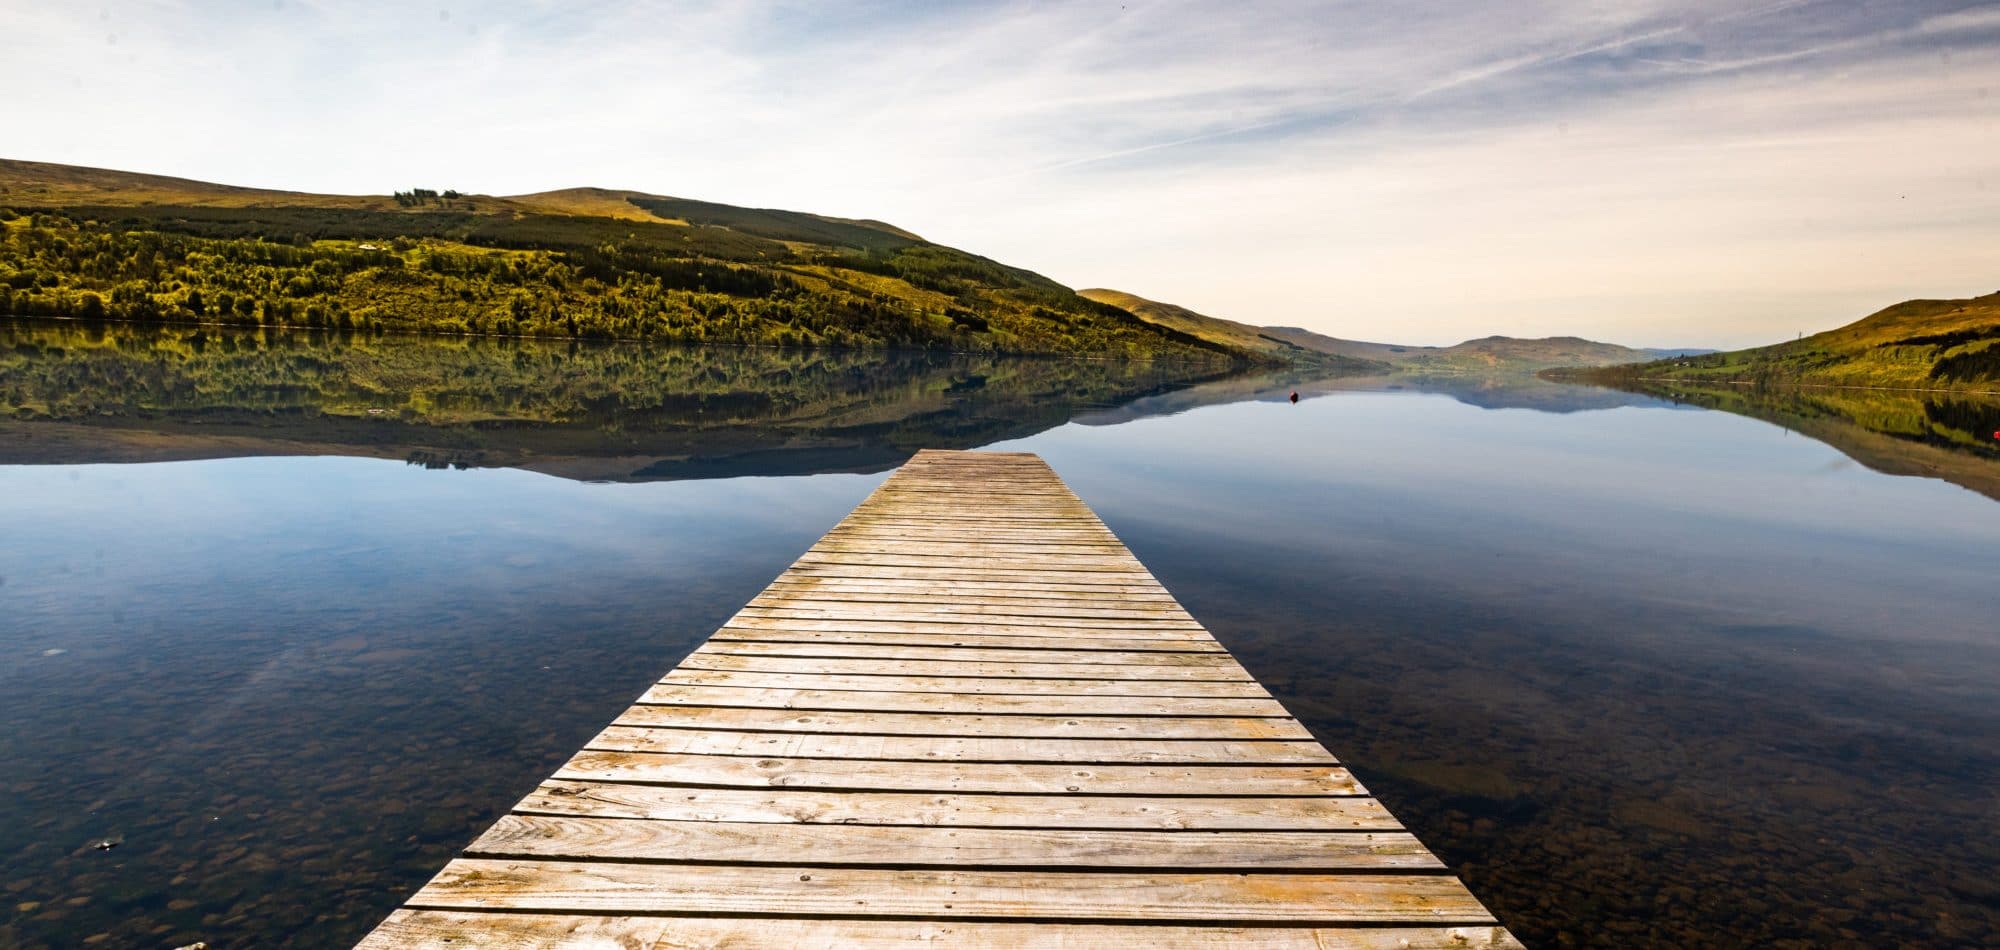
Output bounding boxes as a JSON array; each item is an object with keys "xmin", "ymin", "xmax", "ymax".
[{"xmin": 556, "ymin": 750, "xmax": 1360, "ymax": 798}]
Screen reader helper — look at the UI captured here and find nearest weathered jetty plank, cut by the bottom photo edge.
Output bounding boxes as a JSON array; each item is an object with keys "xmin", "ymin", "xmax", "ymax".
[{"xmin": 360, "ymin": 910, "xmax": 1520, "ymax": 950}]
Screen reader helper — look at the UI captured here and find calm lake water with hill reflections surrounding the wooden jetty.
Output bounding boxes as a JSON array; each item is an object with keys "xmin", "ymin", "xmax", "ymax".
[{"xmin": 0, "ymin": 326, "xmax": 2000, "ymax": 948}]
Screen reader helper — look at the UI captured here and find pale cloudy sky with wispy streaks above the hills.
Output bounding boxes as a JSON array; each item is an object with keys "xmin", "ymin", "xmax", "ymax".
[{"xmin": 0, "ymin": 0, "xmax": 2000, "ymax": 346}]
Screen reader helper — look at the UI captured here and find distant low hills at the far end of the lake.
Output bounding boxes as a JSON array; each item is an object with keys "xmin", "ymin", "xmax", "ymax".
[{"xmin": 1078, "ymin": 288, "xmax": 1708, "ymax": 374}]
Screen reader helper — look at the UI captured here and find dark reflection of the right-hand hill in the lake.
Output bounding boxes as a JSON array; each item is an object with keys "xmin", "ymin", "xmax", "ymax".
[{"xmin": 1592, "ymin": 382, "xmax": 2000, "ymax": 500}]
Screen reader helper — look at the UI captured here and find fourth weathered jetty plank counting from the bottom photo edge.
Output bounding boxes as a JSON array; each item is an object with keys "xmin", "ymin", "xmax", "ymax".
[{"xmin": 516, "ymin": 780, "xmax": 1402, "ymax": 832}]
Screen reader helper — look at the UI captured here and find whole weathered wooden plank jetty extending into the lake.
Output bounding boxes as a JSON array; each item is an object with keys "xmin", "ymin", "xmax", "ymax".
[{"xmin": 360, "ymin": 452, "xmax": 1520, "ymax": 948}]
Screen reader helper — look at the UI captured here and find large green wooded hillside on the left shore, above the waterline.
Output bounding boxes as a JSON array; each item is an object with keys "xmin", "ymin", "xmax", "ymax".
[{"xmin": 0, "ymin": 160, "xmax": 1254, "ymax": 364}]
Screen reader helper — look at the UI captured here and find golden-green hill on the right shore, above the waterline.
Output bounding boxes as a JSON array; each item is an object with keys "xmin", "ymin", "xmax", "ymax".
[{"xmin": 1570, "ymin": 292, "xmax": 2000, "ymax": 392}]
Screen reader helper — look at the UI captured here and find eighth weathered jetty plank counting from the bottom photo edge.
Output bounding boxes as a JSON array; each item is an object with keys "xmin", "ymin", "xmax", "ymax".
[{"xmin": 640, "ymin": 684, "xmax": 1286, "ymax": 718}]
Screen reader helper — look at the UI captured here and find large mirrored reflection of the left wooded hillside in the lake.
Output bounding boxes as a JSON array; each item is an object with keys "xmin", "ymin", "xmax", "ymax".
[{"xmin": 0, "ymin": 324, "xmax": 1214, "ymax": 478}]
